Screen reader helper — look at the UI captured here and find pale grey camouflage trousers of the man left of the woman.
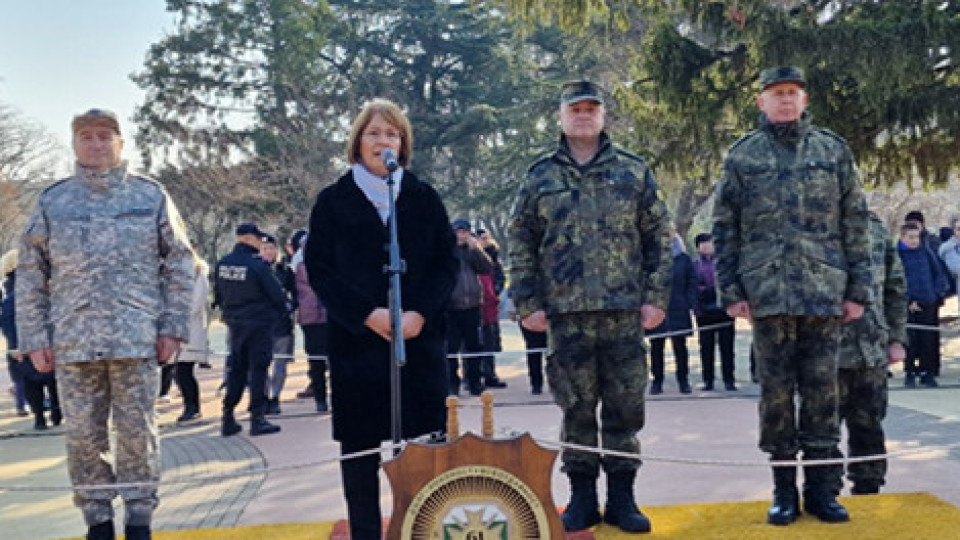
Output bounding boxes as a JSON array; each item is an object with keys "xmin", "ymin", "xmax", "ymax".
[{"xmin": 57, "ymin": 358, "xmax": 160, "ymax": 526}]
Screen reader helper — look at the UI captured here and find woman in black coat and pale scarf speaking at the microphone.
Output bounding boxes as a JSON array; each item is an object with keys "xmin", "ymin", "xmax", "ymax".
[{"xmin": 304, "ymin": 100, "xmax": 457, "ymax": 540}]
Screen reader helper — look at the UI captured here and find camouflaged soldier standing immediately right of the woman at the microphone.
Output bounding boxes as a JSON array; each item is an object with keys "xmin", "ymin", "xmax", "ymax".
[{"xmin": 509, "ymin": 81, "xmax": 673, "ymax": 532}]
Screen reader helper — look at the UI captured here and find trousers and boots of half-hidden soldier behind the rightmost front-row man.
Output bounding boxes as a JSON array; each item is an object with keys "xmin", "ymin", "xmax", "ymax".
[{"xmin": 838, "ymin": 367, "xmax": 887, "ymax": 488}]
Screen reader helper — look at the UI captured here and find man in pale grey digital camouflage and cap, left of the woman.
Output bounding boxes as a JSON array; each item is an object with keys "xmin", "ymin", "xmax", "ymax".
[{"xmin": 17, "ymin": 109, "xmax": 193, "ymax": 539}]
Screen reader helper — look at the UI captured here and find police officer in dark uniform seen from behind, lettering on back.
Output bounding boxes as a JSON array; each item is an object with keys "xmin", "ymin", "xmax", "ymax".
[{"xmin": 214, "ymin": 223, "xmax": 289, "ymax": 437}]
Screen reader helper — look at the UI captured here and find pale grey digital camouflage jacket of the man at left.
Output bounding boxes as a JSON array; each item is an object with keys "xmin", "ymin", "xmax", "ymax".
[{"xmin": 17, "ymin": 160, "xmax": 193, "ymax": 363}]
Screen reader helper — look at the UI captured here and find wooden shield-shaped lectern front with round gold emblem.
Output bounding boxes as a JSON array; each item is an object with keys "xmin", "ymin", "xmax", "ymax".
[{"xmin": 383, "ymin": 392, "xmax": 564, "ymax": 540}]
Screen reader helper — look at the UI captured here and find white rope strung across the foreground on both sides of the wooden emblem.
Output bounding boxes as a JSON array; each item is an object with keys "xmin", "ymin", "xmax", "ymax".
[{"xmin": 0, "ymin": 430, "xmax": 960, "ymax": 492}]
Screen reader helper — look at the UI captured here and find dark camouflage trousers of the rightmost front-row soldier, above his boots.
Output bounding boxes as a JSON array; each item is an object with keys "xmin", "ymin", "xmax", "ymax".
[{"xmin": 753, "ymin": 316, "xmax": 841, "ymax": 459}]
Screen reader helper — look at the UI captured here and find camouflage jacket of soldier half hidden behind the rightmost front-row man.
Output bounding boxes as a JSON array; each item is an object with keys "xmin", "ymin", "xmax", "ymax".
[{"xmin": 839, "ymin": 214, "xmax": 907, "ymax": 368}]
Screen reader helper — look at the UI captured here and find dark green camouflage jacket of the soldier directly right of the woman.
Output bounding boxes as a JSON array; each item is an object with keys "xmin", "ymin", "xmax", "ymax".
[{"xmin": 508, "ymin": 134, "xmax": 673, "ymax": 319}]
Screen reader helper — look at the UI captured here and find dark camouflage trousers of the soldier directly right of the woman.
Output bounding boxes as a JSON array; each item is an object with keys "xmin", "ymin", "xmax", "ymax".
[{"xmin": 546, "ymin": 311, "xmax": 648, "ymax": 475}]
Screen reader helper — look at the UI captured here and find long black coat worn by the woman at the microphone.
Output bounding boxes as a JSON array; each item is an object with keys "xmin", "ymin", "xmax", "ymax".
[{"xmin": 304, "ymin": 171, "xmax": 457, "ymax": 444}]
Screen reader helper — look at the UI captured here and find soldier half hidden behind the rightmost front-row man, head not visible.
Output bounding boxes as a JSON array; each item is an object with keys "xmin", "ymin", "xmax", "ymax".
[{"xmin": 838, "ymin": 213, "xmax": 907, "ymax": 490}]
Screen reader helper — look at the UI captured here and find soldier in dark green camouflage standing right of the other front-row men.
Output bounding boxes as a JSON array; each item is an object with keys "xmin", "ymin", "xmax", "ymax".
[{"xmin": 713, "ymin": 67, "xmax": 871, "ymax": 525}]
